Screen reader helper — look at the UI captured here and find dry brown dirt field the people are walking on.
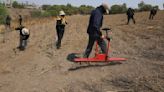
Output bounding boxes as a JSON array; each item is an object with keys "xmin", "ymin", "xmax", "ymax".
[{"xmin": 0, "ymin": 11, "xmax": 164, "ymax": 92}]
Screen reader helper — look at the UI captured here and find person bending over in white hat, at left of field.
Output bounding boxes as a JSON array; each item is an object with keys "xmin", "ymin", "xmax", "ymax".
[{"xmin": 15, "ymin": 26, "xmax": 30, "ymax": 51}]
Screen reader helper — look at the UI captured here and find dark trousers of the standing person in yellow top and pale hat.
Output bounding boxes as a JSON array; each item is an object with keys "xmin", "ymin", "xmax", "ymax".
[{"xmin": 56, "ymin": 28, "xmax": 64, "ymax": 49}]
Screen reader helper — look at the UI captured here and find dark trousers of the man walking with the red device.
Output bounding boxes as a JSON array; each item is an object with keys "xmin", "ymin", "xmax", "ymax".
[{"xmin": 84, "ymin": 35, "xmax": 107, "ymax": 58}]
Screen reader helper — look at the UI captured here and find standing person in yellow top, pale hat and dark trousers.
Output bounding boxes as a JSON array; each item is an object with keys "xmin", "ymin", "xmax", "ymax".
[{"xmin": 56, "ymin": 11, "xmax": 67, "ymax": 49}]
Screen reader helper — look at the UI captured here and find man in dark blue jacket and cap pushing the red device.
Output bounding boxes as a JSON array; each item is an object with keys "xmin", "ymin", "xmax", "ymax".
[{"xmin": 83, "ymin": 3, "xmax": 109, "ymax": 58}]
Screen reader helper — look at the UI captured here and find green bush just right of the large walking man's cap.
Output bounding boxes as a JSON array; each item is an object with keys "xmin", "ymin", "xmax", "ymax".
[{"xmin": 110, "ymin": 3, "xmax": 127, "ymax": 14}]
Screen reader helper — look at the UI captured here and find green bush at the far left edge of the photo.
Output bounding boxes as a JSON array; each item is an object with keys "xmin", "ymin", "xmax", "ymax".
[{"xmin": 0, "ymin": 5, "xmax": 7, "ymax": 24}]
